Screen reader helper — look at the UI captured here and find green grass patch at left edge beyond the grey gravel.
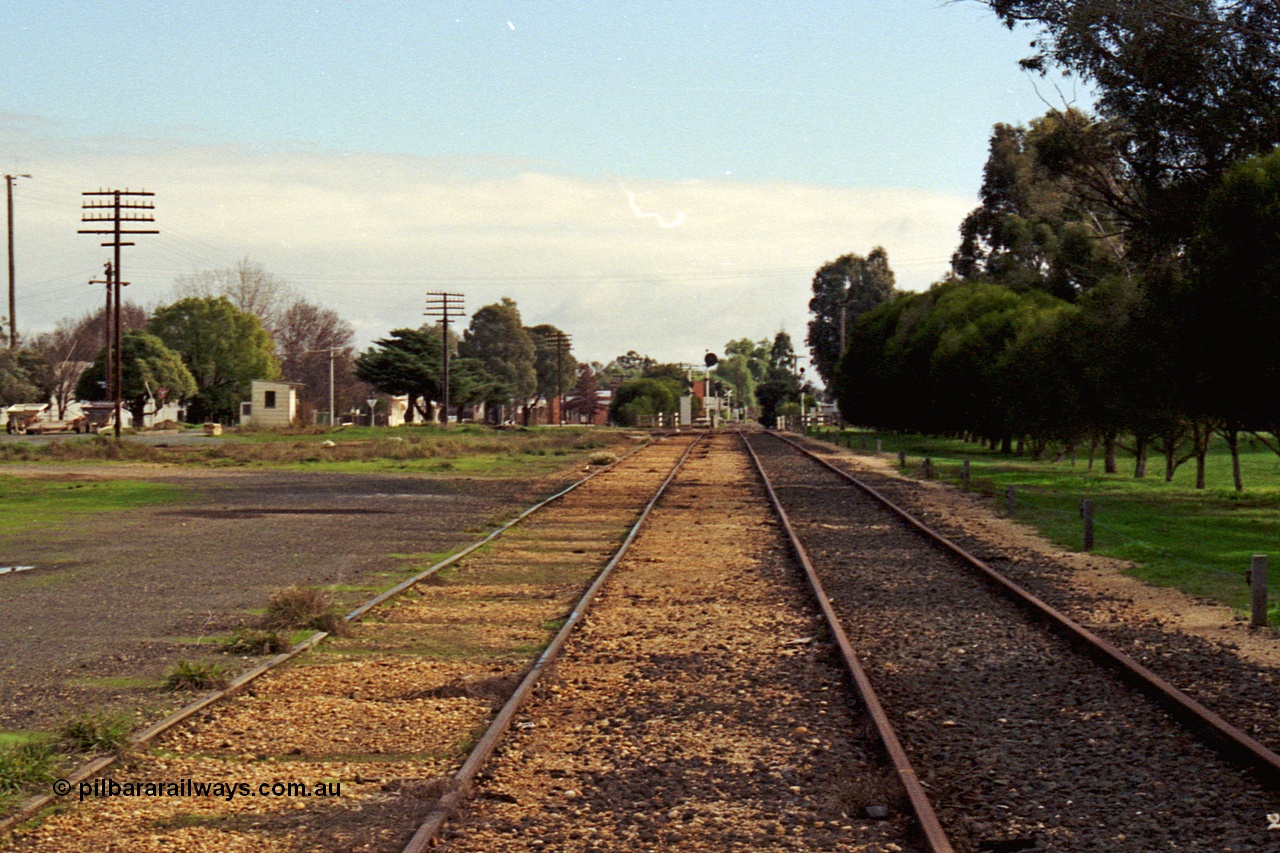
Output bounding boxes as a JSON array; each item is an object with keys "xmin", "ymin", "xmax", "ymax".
[{"xmin": 0, "ymin": 474, "xmax": 187, "ymax": 535}]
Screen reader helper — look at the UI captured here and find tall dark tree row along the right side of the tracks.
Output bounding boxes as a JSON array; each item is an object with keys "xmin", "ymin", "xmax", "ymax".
[{"xmin": 809, "ymin": 0, "xmax": 1280, "ymax": 489}]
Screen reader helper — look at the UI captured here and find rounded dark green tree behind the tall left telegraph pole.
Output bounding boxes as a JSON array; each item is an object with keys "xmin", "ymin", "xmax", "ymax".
[{"xmin": 76, "ymin": 330, "xmax": 196, "ymax": 427}]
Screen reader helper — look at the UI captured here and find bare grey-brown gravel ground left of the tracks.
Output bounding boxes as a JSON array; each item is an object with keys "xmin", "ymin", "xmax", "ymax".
[{"xmin": 0, "ymin": 466, "xmax": 573, "ymax": 730}]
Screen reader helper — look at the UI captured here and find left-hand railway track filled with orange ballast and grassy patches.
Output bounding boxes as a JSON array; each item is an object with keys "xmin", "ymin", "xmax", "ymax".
[{"xmin": 8, "ymin": 437, "xmax": 692, "ymax": 853}]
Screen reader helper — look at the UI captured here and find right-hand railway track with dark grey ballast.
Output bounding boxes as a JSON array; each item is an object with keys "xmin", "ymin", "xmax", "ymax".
[{"xmin": 749, "ymin": 435, "xmax": 1280, "ymax": 852}]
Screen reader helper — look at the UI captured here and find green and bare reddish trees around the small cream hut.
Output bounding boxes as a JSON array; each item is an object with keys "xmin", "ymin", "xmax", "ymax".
[{"xmin": 0, "ymin": 259, "xmax": 366, "ymax": 424}]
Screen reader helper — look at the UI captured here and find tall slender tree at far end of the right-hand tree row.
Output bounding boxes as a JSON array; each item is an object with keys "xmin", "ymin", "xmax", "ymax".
[{"xmin": 808, "ymin": 246, "xmax": 893, "ymax": 384}]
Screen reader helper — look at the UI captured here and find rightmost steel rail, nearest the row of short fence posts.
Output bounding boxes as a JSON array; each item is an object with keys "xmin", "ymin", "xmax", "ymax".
[{"xmin": 774, "ymin": 435, "xmax": 1280, "ymax": 790}]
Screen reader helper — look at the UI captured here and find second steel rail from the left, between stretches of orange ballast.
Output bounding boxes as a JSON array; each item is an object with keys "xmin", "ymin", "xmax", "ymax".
[{"xmin": 403, "ymin": 433, "xmax": 707, "ymax": 853}]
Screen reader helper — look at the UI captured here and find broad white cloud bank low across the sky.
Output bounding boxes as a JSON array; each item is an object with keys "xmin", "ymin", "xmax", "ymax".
[{"xmin": 0, "ymin": 122, "xmax": 974, "ymax": 361}]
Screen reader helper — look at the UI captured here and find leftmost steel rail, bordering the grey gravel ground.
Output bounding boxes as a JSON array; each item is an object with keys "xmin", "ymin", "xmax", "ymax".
[{"xmin": 0, "ymin": 442, "xmax": 652, "ymax": 836}]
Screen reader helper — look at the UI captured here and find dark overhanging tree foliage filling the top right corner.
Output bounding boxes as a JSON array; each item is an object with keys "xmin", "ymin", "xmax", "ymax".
[{"xmin": 979, "ymin": 0, "xmax": 1280, "ymax": 257}]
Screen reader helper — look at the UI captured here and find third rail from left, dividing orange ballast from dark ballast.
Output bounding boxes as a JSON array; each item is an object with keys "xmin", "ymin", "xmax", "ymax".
[{"xmin": 739, "ymin": 432, "xmax": 954, "ymax": 853}]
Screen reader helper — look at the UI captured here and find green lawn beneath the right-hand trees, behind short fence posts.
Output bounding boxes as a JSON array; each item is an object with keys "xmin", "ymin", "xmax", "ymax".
[{"xmin": 827, "ymin": 430, "xmax": 1280, "ymax": 611}]
